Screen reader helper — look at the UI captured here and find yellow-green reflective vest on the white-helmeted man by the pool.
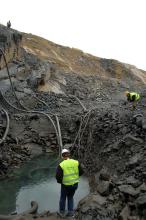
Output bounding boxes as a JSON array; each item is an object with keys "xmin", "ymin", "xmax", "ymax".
[{"xmin": 60, "ymin": 159, "xmax": 79, "ymax": 185}]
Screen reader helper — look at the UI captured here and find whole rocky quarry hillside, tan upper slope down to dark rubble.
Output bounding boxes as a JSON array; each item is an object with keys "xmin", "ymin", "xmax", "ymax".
[{"xmin": 0, "ymin": 26, "xmax": 146, "ymax": 220}]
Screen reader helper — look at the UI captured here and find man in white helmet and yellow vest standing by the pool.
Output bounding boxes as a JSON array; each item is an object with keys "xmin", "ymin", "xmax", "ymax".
[{"xmin": 56, "ymin": 149, "xmax": 83, "ymax": 216}]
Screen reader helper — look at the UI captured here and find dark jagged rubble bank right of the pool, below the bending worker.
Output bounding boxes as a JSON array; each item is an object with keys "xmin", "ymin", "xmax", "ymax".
[{"xmin": 74, "ymin": 102, "xmax": 146, "ymax": 220}]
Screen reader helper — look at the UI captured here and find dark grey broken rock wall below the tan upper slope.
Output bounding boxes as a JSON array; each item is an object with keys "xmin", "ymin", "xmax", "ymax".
[{"xmin": 0, "ymin": 24, "xmax": 146, "ymax": 220}]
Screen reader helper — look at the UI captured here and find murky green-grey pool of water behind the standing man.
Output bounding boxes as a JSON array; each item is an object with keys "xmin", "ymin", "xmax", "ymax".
[{"xmin": 0, "ymin": 155, "xmax": 89, "ymax": 214}]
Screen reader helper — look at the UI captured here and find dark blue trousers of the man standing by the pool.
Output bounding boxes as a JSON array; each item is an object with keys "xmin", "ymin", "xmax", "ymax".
[{"xmin": 59, "ymin": 183, "xmax": 78, "ymax": 212}]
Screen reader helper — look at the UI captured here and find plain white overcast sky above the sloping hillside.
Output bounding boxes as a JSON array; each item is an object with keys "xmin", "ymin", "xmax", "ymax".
[{"xmin": 0, "ymin": 0, "xmax": 146, "ymax": 70}]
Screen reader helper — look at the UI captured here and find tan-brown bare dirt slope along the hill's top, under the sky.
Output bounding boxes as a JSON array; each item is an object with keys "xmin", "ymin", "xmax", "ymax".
[{"xmin": 22, "ymin": 34, "xmax": 146, "ymax": 83}]
